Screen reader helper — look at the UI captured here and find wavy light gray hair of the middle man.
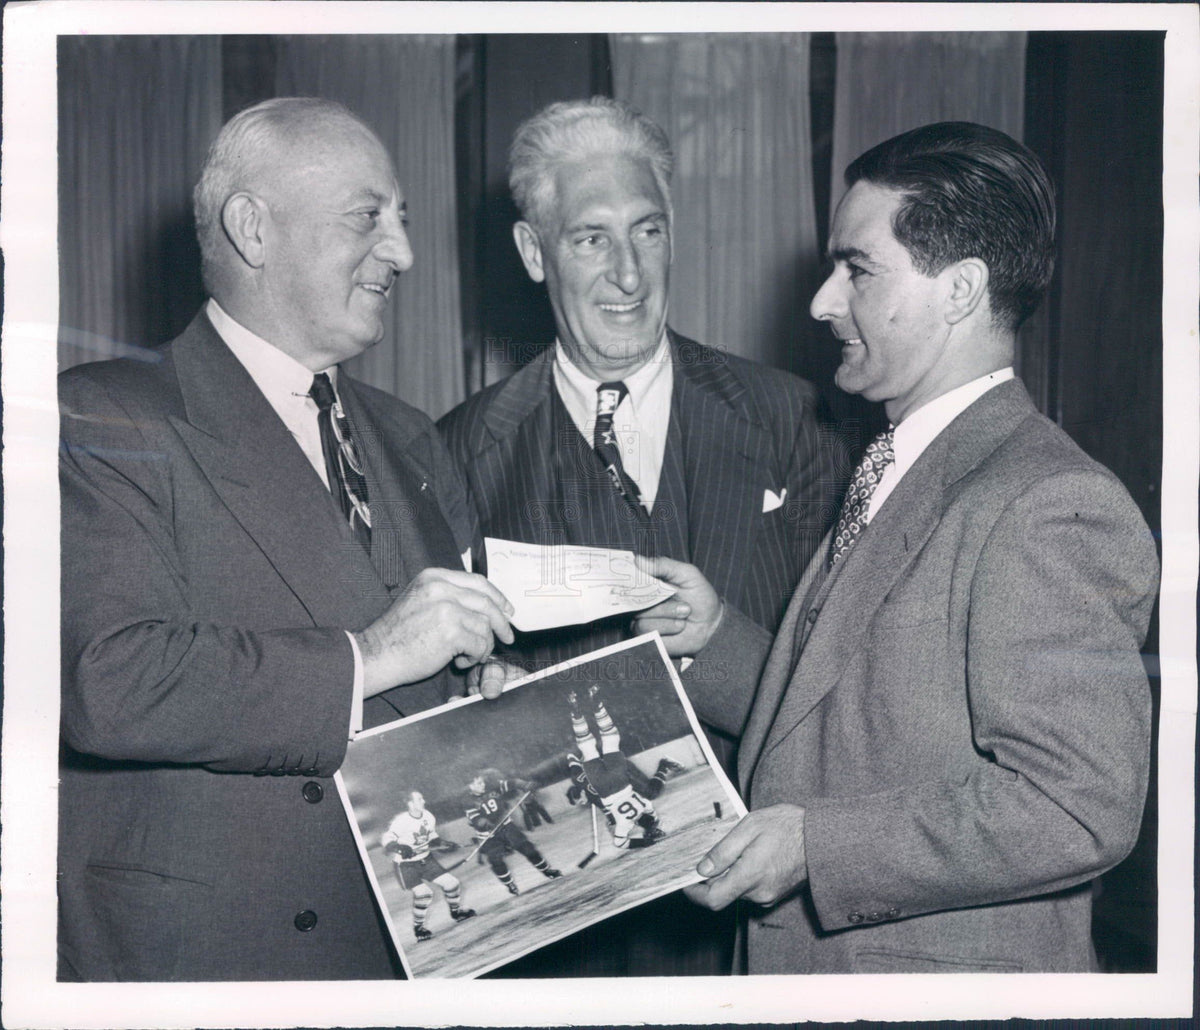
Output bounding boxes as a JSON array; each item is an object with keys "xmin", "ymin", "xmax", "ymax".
[{"xmin": 509, "ymin": 96, "xmax": 674, "ymax": 230}]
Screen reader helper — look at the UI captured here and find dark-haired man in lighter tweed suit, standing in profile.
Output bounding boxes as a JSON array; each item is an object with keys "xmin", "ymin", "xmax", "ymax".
[{"xmin": 638, "ymin": 122, "xmax": 1158, "ymax": 972}]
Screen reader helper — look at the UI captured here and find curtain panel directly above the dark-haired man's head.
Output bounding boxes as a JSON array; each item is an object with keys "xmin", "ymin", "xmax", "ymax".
[{"xmin": 829, "ymin": 32, "xmax": 1026, "ymax": 217}]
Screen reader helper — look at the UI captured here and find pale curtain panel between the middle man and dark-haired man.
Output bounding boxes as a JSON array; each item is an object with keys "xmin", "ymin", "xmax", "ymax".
[{"xmin": 610, "ymin": 34, "xmax": 818, "ymax": 367}]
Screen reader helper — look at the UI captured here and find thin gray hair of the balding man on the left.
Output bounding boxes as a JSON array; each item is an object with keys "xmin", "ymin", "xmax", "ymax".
[{"xmin": 192, "ymin": 96, "xmax": 374, "ymax": 294}]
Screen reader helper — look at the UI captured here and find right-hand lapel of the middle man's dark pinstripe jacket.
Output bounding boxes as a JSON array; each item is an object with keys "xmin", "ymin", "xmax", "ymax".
[{"xmin": 671, "ymin": 333, "xmax": 780, "ymax": 603}]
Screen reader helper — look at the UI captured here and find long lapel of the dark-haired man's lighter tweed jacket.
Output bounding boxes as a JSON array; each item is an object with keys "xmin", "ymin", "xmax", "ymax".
[{"xmin": 755, "ymin": 381, "xmax": 1033, "ymax": 760}]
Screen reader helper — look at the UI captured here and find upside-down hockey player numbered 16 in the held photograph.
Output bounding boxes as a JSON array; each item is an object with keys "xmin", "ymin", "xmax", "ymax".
[{"xmin": 566, "ymin": 683, "xmax": 680, "ymax": 848}]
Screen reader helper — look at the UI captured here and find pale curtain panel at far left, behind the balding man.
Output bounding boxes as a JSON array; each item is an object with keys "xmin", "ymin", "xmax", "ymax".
[{"xmin": 59, "ymin": 36, "xmax": 221, "ymax": 369}]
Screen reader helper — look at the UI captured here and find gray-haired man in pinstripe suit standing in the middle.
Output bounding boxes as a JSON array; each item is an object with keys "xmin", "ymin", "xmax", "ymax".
[{"xmin": 439, "ymin": 97, "xmax": 847, "ymax": 975}]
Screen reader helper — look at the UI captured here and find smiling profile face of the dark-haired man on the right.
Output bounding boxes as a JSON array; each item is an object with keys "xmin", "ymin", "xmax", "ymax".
[{"xmin": 810, "ymin": 180, "xmax": 950, "ymax": 423}]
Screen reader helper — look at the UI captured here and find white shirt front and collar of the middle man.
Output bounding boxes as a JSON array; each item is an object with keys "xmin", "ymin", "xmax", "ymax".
[{"xmin": 554, "ymin": 331, "xmax": 674, "ymax": 511}]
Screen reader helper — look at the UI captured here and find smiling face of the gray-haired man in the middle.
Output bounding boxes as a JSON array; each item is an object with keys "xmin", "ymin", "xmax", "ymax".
[{"xmin": 522, "ymin": 154, "xmax": 671, "ymax": 381}]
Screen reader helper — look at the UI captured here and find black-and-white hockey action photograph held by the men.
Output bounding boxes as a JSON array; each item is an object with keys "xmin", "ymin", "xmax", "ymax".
[{"xmin": 336, "ymin": 635, "xmax": 745, "ymax": 977}]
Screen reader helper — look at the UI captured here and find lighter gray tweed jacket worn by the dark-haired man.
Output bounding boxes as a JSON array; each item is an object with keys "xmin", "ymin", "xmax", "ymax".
[{"xmin": 685, "ymin": 382, "xmax": 1158, "ymax": 972}]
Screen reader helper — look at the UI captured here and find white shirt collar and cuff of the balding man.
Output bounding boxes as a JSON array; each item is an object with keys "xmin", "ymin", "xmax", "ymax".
[{"xmin": 205, "ymin": 292, "xmax": 362, "ymax": 739}]
